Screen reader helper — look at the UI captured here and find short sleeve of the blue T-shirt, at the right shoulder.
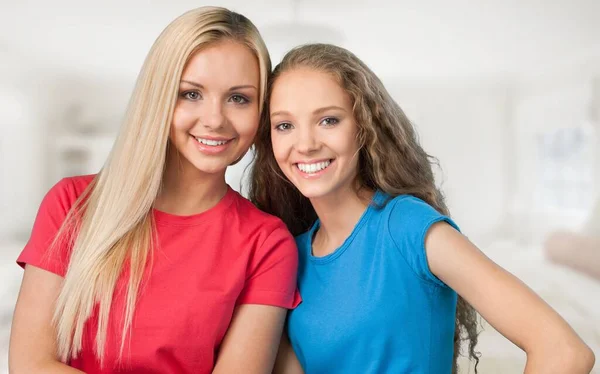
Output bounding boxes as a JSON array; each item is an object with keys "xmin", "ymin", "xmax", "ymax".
[{"xmin": 388, "ymin": 195, "xmax": 460, "ymax": 287}]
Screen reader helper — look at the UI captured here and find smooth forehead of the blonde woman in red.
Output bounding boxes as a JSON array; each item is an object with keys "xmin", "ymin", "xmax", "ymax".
[{"xmin": 182, "ymin": 40, "xmax": 260, "ymax": 87}]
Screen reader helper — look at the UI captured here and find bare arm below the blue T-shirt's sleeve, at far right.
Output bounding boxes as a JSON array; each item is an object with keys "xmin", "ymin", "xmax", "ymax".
[{"xmin": 425, "ymin": 222, "xmax": 595, "ymax": 374}]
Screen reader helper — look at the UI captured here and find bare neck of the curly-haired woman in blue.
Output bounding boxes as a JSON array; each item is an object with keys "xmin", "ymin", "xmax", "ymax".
[{"xmin": 311, "ymin": 187, "xmax": 374, "ymax": 255}]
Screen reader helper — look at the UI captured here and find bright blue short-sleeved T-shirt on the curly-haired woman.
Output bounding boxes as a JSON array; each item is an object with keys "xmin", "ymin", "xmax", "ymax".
[{"xmin": 287, "ymin": 192, "xmax": 458, "ymax": 374}]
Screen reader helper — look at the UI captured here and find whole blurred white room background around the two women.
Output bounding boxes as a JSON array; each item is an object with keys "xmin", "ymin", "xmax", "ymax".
[{"xmin": 0, "ymin": 0, "xmax": 600, "ymax": 373}]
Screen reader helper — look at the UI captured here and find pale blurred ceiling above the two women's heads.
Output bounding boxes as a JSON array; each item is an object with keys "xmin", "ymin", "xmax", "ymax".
[{"xmin": 0, "ymin": 0, "xmax": 600, "ymax": 79}]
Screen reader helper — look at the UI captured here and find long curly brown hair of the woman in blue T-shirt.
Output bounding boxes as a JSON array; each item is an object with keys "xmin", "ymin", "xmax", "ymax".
[{"xmin": 249, "ymin": 44, "xmax": 480, "ymax": 373}]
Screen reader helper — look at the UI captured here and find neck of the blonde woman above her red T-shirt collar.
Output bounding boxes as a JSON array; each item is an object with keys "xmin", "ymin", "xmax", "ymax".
[{"xmin": 154, "ymin": 148, "xmax": 227, "ymax": 216}]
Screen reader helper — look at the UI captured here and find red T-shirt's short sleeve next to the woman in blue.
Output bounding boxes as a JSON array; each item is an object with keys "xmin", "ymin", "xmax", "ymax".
[{"xmin": 237, "ymin": 223, "xmax": 301, "ymax": 309}]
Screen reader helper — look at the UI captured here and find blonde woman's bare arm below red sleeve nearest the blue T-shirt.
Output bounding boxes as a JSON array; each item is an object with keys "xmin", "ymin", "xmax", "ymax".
[{"xmin": 213, "ymin": 304, "xmax": 287, "ymax": 374}]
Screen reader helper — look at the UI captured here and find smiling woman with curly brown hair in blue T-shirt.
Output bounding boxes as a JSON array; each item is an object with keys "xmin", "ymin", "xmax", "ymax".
[{"xmin": 250, "ymin": 44, "xmax": 594, "ymax": 374}]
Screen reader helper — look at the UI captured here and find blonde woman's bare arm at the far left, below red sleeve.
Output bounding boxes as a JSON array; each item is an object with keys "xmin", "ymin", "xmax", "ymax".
[{"xmin": 8, "ymin": 265, "xmax": 82, "ymax": 374}]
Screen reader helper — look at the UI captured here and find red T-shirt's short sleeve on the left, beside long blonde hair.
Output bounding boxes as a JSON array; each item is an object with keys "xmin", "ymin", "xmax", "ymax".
[{"xmin": 17, "ymin": 178, "xmax": 77, "ymax": 277}]
